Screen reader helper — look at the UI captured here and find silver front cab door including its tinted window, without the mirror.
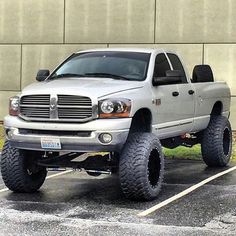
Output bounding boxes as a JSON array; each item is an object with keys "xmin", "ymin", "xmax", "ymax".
[{"xmin": 152, "ymin": 53, "xmax": 181, "ymax": 138}]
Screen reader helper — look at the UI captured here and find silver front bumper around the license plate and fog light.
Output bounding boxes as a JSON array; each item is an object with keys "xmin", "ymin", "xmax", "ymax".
[{"xmin": 4, "ymin": 116, "xmax": 131, "ymax": 152}]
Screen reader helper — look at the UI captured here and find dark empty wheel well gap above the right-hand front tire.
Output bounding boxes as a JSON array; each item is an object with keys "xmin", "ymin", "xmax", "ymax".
[{"xmin": 130, "ymin": 108, "xmax": 152, "ymax": 133}]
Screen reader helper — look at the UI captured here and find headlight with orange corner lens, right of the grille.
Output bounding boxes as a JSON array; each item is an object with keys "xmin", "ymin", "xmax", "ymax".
[{"xmin": 99, "ymin": 99, "xmax": 131, "ymax": 118}]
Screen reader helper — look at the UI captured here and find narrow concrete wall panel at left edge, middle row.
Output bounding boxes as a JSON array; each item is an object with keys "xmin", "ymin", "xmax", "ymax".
[{"xmin": 0, "ymin": 45, "xmax": 21, "ymax": 90}]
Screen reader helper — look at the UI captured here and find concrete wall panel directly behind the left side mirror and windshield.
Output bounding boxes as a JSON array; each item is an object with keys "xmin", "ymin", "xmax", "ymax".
[{"xmin": 22, "ymin": 44, "xmax": 106, "ymax": 89}]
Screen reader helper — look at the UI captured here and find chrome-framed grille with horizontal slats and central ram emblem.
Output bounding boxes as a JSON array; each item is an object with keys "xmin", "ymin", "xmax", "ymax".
[{"xmin": 20, "ymin": 95, "xmax": 93, "ymax": 122}]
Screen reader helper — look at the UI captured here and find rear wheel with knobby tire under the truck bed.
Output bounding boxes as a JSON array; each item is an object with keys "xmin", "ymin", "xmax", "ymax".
[{"xmin": 201, "ymin": 116, "xmax": 232, "ymax": 167}]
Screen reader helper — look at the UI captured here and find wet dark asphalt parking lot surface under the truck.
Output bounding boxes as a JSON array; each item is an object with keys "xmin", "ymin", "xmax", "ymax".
[{"xmin": 0, "ymin": 160, "xmax": 236, "ymax": 235}]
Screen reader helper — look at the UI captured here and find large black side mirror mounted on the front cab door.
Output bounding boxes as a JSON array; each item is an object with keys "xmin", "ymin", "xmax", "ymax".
[{"xmin": 152, "ymin": 70, "xmax": 184, "ymax": 86}]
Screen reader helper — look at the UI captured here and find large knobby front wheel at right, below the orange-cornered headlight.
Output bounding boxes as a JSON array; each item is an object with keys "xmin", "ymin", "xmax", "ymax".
[{"xmin": 119, "ymin": 133, "xmax": 164, "ymax": 201}]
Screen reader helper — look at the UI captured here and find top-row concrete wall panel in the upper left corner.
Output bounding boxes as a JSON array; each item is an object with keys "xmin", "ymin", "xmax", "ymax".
[{"xmin": 0, "ymin": 0, "xmax": 64, "ymax": 43}]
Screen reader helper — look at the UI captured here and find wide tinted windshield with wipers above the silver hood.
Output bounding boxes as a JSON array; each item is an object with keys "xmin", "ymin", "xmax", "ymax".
[{"xmin": 49, "ymin": 51, "xmax": 150, "ymax": 81}]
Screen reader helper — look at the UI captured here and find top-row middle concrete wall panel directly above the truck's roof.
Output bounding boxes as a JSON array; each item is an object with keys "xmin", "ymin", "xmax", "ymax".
[{"xmin": 65, "ymin": 0, "xmax": 155, "ymax": 43}]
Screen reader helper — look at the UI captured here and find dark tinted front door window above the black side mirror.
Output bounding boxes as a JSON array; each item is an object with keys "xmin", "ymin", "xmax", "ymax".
[{"xmin": 153, "ymin": 53, "xmax": 170, "ymax": 77}]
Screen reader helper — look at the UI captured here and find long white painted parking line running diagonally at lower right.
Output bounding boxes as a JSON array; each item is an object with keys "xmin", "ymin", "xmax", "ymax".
[{"xmin": 138, "ymin": 166, "xmax": 236, "ymax": 216}]
